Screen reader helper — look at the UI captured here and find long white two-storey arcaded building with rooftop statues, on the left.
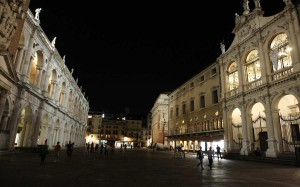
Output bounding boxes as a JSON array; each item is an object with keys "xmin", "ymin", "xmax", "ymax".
[{"xmin": 0, "ymin": 3, "xmax": 89, "ymax": 150}]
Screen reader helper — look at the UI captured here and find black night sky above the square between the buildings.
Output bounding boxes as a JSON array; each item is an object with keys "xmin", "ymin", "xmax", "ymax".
[{"xmin": 30, "ymin": 0, "xmax": 292, "ymax": 114}]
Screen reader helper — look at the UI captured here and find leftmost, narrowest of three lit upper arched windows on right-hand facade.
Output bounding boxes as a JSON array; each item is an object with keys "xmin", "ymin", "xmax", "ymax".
[{"xmin": 227, "ymin": 62, "xmax": 239, "ymax": 90}]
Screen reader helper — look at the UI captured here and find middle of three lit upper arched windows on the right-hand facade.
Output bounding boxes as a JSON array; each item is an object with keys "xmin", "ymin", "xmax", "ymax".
[{"xmin": 246, "ymin": 50, "xmax": 261, "ymax": 82}]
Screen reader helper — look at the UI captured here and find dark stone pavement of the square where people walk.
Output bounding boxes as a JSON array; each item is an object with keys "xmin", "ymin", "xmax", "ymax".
[{"xmin": 0, "ymin": 148, "xmax": 300, "ymax": 187}]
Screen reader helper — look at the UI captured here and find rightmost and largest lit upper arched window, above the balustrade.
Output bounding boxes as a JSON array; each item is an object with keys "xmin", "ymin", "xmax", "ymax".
[{"xmin": 270, "ymin": 33, "xmax": 292, "ymax": 72}]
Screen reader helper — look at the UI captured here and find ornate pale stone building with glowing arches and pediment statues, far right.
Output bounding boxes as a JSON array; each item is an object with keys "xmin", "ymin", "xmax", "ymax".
[{"xmin": 217, "ymin": 0, "xmax": 300, "ymax": 157}]
